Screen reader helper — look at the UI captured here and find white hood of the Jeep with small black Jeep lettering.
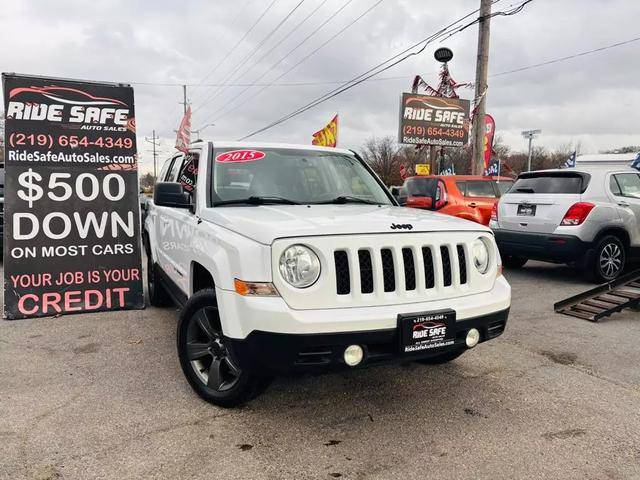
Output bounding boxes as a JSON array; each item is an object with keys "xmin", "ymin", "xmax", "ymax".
[{"xmin": 202, "ymin": 205, "xmax": 490, "ymax": 245}]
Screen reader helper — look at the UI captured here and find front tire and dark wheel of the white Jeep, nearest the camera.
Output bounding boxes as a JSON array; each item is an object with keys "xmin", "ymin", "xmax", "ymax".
[{"xmin": 177, "ymin": 288, "xmax": 268, "ymax": 408}]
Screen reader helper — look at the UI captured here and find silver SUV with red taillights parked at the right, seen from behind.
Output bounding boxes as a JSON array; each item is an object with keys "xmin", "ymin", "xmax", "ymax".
[{"xmin": 489, "ymin": 166, "xmax": 640, "ymax": 282}]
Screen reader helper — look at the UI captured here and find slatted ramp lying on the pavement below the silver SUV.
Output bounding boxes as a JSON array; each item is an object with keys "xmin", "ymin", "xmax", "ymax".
[{"xmin": 553, "ymin": 270, "xmax": 640, "ymax": 322}]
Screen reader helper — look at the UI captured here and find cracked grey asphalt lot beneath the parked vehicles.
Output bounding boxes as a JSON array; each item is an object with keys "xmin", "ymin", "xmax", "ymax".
[{"xmin": 0, "ymin": 262, "xmax": 640, "ymax": 479}]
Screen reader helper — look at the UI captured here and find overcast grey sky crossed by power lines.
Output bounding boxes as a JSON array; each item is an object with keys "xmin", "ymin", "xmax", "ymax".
[{"xmin": 0, "ymin": 0, "xmax": 640, "ymax": 169}]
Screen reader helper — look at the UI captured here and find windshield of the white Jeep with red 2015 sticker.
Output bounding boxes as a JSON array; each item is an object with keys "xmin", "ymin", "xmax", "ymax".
[{"xmin": 212, "ymin": 148, "xmax": 391, "ymax": 205}]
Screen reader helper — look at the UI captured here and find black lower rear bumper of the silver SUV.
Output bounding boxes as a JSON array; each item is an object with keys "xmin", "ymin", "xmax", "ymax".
[{"xmin": 493, "ymin": 229, "xmax": 591, "ymax": 263}]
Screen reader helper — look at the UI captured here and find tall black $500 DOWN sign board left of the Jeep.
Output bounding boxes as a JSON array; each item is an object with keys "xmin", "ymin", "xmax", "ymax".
[{"xmin": 2, "ymin": 74, "xmax": 144, "ymax": 319}]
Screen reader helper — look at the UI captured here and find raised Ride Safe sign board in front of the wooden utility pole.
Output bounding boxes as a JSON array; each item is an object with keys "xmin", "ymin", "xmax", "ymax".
[{"xmin": 399, "ymin": 93, "xmax": 470, "ymax": 147}]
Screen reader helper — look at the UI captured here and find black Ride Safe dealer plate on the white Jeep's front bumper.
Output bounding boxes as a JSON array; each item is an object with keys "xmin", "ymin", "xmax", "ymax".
[{"xmin": 398, "ymin": 310, "xmax": 456, "ymax": 353}]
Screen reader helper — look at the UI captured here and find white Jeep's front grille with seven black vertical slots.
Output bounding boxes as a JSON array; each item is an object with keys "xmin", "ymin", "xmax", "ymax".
[{"xmin": 333, "ymin": 244, "xmax": 468, "ymax": 295}]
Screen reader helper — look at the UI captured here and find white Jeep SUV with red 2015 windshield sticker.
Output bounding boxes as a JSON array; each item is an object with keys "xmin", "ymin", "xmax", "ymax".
[{"xmin": 144, "ymin": 142, "xmax": 511, "ymax": 406}]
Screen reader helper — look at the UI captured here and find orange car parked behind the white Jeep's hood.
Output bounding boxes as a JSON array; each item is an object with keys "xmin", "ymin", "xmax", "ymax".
[{"xmin": 398, "ymin": 175, "xmax": 513, "ymax": 225}]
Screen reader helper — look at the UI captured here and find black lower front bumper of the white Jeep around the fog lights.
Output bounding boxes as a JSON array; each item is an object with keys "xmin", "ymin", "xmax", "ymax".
[{"xmin": 228, "ymin": 309, "xmax": 509, "ymax": 375}]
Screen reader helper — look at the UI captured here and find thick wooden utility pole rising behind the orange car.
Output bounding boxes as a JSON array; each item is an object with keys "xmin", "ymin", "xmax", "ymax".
[{"xmin": 471, "ymin": 0, "xmax": 491, "ymax": 175}]
